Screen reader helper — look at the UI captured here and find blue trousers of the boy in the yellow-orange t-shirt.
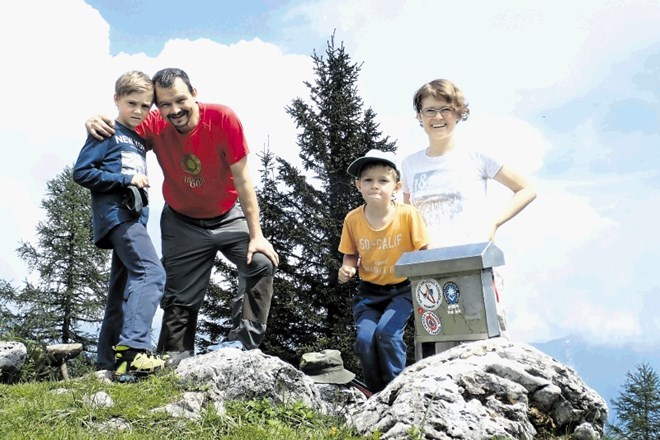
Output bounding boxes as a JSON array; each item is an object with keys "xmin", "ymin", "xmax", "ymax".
[{"xmin": 353, "ymin": 281, "xmax": 413, "ymax": 392}]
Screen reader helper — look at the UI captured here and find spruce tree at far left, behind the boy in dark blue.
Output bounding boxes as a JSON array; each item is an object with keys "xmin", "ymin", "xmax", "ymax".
[{"xmin": 0, "ymin": 167, "xmax": 109, "ymax": 345}]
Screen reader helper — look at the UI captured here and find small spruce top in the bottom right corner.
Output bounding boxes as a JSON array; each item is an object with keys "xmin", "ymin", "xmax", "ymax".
[{"xmin": 609, "ymin": 363, "xmax": 660, "ymax": 440}]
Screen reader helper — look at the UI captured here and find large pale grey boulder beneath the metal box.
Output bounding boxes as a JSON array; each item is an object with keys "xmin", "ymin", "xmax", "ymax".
[{"xmin": 351, "ymin": 338, "xmax": 607, "ymax": 440}]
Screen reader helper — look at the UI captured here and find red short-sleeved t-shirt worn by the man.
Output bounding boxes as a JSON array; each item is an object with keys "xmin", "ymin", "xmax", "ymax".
[{"xmin": 136, "ymin": 103, "xmax": 249, "ymax": 218}]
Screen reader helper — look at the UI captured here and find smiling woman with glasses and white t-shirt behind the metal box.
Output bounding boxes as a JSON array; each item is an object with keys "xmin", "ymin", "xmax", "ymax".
[{"xmin": 401, "ymin": 79, "xmax": 536, "ymax": 336}]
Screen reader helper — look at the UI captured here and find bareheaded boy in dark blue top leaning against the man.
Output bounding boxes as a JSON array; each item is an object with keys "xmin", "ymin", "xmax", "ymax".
[{"xmin": 73, "ymin": 71, "xmax": 165, "ymax": 381}]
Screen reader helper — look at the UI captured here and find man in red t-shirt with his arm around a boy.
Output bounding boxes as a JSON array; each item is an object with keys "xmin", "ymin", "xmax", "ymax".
[{"xmin": 85, "ymin": 68, "xmax": 279, "ymax": 362}]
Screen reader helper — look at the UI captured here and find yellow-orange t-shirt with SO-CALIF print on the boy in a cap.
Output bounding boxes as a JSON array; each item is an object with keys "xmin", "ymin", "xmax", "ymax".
[{"xmin": 339, "ymin": 202, "xmax": 430, "ymax": 286}]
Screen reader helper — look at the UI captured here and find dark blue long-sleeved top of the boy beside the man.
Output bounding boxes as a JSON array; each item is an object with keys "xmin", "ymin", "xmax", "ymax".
[{"xmin": 73, "ymin": 122, "xmax": 149, "ymax": 249}]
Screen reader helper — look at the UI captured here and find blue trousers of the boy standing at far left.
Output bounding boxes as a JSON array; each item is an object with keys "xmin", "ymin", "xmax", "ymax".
[{"xmin": 96, "ymin": 220, "xmax": 165, "ymax": 370}]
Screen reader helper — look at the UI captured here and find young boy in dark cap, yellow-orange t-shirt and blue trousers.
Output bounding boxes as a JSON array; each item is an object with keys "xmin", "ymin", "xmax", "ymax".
[{"xmin": 339, "ymin": 150, "xmax": 429, "ymax": 392}]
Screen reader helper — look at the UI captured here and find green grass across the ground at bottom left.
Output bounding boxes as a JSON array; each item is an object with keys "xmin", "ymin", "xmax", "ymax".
[{"xmin": 0, "ymin": 372, "xmax": 380, "ymax": 440}]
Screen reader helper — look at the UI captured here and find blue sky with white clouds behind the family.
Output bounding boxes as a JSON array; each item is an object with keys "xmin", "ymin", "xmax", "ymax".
[{"xmin": 0, "ymin": 0, "xmax": 660, "ymax": 348}]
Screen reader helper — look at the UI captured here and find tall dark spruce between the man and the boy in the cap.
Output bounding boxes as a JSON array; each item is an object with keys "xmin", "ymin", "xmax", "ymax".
[{"xmin": 205, "ymin": 36, "xmax": 396, "ymax": 372}]
